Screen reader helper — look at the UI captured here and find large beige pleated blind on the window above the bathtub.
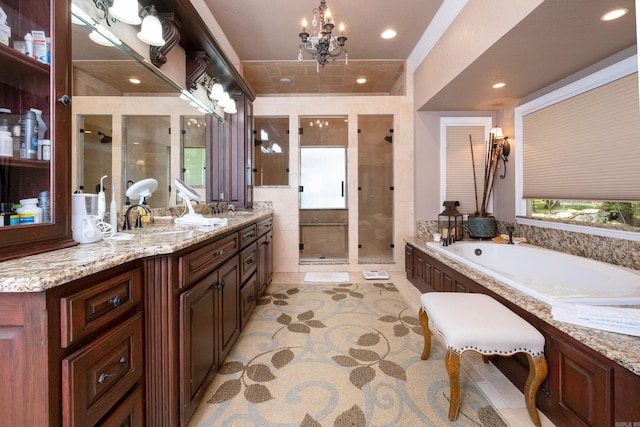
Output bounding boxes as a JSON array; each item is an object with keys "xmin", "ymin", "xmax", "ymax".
[{"xmin": 522, "ymin": 73, "xmax": 640, "ymax": 201}]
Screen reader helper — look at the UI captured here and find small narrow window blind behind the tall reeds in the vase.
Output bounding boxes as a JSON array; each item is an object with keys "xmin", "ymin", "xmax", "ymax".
[{"xmin": 446, "ymin": 126, "xmax": 486, "ymax": 214}]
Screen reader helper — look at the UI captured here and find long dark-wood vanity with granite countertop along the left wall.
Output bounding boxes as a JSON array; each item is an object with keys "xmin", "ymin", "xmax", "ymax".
[{"xmin": 0, "ymin": 211, "xmax": 273, "ymax": 427}]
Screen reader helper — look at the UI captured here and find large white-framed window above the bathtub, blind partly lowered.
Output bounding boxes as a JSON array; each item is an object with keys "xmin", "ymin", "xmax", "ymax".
[{"xmin": 515, "ymin": 56, "xmax": 640, "ymax": 240}]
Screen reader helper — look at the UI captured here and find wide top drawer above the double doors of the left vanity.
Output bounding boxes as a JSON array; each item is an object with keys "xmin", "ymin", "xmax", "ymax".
[{"xmin": 178, "ymin": 233, "xmax": 240, "ymax": 288}]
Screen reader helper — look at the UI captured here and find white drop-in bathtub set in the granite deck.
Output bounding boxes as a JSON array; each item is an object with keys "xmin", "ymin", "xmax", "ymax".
[{"xmin": 427, "ymin": 241, "xmax": 640, "ymax": 305}]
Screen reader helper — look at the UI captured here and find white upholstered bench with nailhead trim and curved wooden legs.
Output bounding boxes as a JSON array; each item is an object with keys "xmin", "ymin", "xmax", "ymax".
[{"xmin": 419, "ymin": 292, "xmax": 547, "ymax": 426}]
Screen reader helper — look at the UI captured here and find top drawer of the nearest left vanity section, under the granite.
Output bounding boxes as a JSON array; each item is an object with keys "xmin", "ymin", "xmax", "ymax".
[{"xmin": 60, "ymin": 268, "xmax": 142, "ymax": 348}]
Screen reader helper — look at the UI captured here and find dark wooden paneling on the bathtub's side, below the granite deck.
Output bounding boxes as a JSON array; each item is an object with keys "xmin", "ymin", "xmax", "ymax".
[{"xmin": 405, "ymin": 245, "xmax": 640, "ymax": 427}]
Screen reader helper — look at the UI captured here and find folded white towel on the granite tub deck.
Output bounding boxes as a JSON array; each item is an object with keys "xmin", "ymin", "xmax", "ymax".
[{"xmin": 551, "ymin": 302, "xmax": 640, "ymax": 337}]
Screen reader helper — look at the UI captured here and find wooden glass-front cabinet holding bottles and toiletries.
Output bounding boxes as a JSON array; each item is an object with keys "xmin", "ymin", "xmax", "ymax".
[{"xmin": 0, "ymin": 0, "xmax": 74, "ymax": 260}]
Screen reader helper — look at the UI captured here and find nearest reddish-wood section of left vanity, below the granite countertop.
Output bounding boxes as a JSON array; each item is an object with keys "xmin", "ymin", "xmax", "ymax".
[{"xmin": 0, "ymin": 263, "xmax": 144, "ymax": 427}]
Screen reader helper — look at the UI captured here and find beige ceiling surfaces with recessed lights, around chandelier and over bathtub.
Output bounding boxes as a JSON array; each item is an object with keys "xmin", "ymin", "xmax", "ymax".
[{"xmin": 199, "ymin": 0, "xmax": 636, "ymax": 110}]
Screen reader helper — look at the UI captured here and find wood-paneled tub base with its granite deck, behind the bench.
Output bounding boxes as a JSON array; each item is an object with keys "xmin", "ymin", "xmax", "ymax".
[{"xmin": 405, "ymin": 239, "xmax": 640, "ymax": 426}]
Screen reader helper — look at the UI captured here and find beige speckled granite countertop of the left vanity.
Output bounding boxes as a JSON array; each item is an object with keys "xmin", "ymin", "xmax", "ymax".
[{"xmin": 0, "ymin": 210, "xmax": 273, "ymax": 298}]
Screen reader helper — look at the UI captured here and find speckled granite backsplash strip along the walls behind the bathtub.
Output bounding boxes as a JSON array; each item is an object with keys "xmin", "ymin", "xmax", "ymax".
[{"xmin": 416, "ymin": 220, "xmax": 640, "ymax": 270}]
